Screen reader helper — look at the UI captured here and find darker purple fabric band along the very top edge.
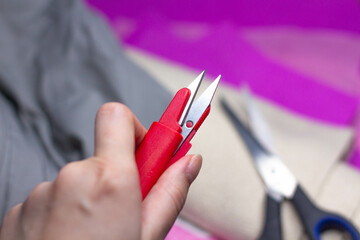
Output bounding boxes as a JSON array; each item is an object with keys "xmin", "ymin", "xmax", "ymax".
[{"xmin": 87, "ymin": 0, "xmax": 360, "ymax": 32}]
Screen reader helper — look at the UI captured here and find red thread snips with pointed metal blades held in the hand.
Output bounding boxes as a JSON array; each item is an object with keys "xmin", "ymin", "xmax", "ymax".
[{"xmin": 135, "ymin": 71, "xmax": 221, "ymax": 199}]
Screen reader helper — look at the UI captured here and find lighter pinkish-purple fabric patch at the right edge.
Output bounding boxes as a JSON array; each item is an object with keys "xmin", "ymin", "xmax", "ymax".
[{"xmin": 245, "ymin": 28, "xmax": 360, "ymax": 97}]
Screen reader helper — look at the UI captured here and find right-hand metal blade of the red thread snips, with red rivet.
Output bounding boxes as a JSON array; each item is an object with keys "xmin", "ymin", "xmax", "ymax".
[{"xmin": 179, "ymin": 75, "xmax": 221, "ymax": 142}]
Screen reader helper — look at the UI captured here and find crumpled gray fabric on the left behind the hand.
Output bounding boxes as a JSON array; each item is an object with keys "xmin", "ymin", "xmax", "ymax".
[{"xmin": 0, "ymin": 0, "xmax": 171, "ymax": 219}]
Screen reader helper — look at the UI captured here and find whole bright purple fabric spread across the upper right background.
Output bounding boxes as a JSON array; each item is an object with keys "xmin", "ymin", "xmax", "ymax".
[{"xmin": 86, "ymin": 0, "xmax": 360, "ymax": 168}]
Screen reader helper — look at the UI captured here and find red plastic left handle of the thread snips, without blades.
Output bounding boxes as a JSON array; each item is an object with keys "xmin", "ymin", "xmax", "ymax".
[{"xmin": 135, "ymin": 88, "xmax": 191, "ymax": 199}]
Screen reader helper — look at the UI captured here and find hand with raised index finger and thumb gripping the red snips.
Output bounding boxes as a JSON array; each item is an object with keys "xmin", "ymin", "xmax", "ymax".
[{"xmin": 0, "ymin": 103, "xmax": 202, "ymax": 240}]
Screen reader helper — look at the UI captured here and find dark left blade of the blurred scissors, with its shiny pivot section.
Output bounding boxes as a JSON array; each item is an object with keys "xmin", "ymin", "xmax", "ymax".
[{"xmin": 221, "ymin": 100, "xmax": 297, "ymax": 201}]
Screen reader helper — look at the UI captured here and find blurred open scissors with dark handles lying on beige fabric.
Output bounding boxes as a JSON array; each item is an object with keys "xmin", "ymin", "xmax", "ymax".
[{"xmin": 221, "ymin": 90, "xmax": 360, "ymax": 240}]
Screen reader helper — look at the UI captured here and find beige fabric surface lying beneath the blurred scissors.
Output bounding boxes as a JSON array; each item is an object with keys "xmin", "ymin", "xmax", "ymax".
[{"xmin": 127, "ymin": 49, "xmax": 360, "ymax": 240}]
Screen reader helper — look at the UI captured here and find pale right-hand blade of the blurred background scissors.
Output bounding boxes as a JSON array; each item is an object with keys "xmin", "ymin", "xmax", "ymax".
[{"xmin": 244, "ymin": 85, "xmax": 276, "ymax": 153}]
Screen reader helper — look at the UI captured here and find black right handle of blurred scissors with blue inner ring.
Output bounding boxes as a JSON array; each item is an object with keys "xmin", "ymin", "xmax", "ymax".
[{"xmin": 292, "ymin": 186, "xmax": 360, "ymax": 240}]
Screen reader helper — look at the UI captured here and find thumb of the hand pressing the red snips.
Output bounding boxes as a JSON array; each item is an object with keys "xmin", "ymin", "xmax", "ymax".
[{"xmin": 142, "ymin": 155, "xmax": 202, "ymax": 239}]
